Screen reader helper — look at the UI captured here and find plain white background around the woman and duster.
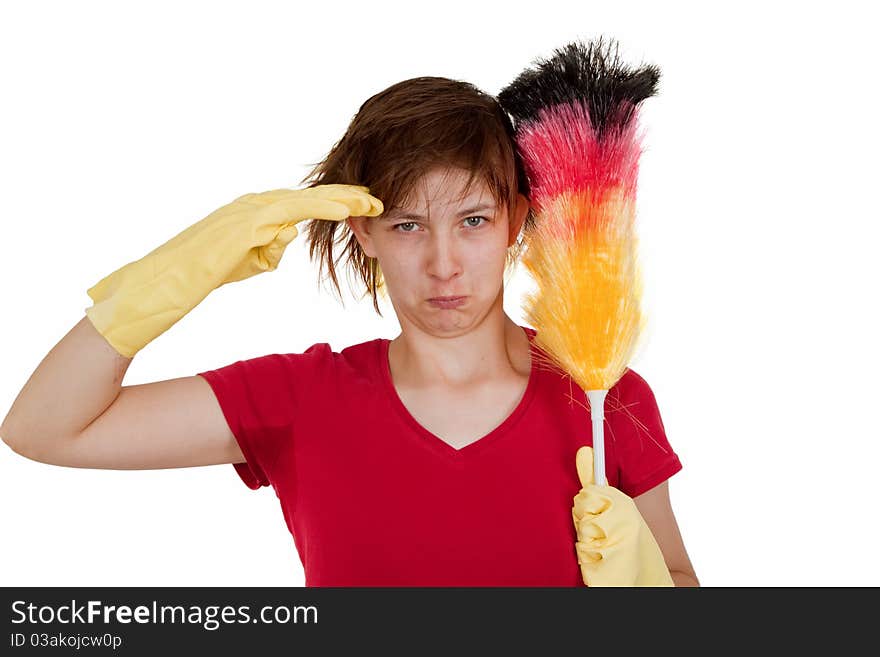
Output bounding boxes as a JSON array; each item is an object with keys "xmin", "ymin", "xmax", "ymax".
[{"xmin": 0, "ymin": 0, "xmax": 880, "ymax": 586}]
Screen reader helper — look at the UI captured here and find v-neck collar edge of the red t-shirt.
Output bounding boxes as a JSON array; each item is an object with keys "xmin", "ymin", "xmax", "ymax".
[{"xmin": 376, "ymin": 326, "xmax": 538, "ymax": 462}]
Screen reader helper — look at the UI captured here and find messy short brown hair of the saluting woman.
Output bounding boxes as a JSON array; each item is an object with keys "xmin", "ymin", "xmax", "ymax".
[{"xmin": 301, "ymin": 77, "xmax": 534, "ymax": 316}]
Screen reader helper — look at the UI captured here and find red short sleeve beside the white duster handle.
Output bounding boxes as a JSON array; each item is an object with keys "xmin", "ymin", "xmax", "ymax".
[{"xmin": 605, "ymin": 369, "xmax": 682, "ymax": 497}]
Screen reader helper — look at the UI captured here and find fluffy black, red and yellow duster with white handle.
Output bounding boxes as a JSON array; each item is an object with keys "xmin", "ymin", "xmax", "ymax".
[{"xmin": 498, "ymin": 38, "xmax": 660, "ymax": 485}]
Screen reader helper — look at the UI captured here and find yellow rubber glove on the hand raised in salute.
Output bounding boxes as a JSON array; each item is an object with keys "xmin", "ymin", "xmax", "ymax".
[{"xmin": 85, "ymin": 184, "xmax": 384, "ymax": 358}]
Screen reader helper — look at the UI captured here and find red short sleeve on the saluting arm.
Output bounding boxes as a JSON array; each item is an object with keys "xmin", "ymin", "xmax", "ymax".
[{"xmin": 198, "ymin": 343, "xmax": 330, "ymax": 490}]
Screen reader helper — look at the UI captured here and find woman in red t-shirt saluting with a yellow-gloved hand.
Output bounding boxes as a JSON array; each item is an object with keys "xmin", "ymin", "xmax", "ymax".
[{"xmin": 0, "ymin": 77, "xmax": 697, "ymax": 586}]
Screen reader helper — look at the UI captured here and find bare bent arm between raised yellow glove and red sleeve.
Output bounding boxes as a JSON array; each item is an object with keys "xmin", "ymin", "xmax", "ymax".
[{"xmin": 0, "ymin": 317, "xmax": 244, "ymax": 470}]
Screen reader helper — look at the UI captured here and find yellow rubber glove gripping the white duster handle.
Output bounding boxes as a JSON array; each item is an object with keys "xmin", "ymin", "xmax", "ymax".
[{"xmin": 572, "ymin": 445, "xmax": 675, "ymax": 586}]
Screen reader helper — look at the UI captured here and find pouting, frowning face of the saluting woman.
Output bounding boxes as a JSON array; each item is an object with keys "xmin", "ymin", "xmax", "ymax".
[{"xmin": 349, "ymin": 168, "xmax": 528, "ymax": 337}]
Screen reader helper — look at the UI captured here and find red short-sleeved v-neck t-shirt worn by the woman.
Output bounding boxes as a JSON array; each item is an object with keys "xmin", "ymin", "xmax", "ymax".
[{"xmin": 199, "ymin": 327, "xmax": 682, "ymax": 586}]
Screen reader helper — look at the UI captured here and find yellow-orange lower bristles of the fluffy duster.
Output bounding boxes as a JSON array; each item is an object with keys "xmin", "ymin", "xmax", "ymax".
[{"xmin": 523, "ymin": 187, "xmax": 646, "ymax": 390}]
